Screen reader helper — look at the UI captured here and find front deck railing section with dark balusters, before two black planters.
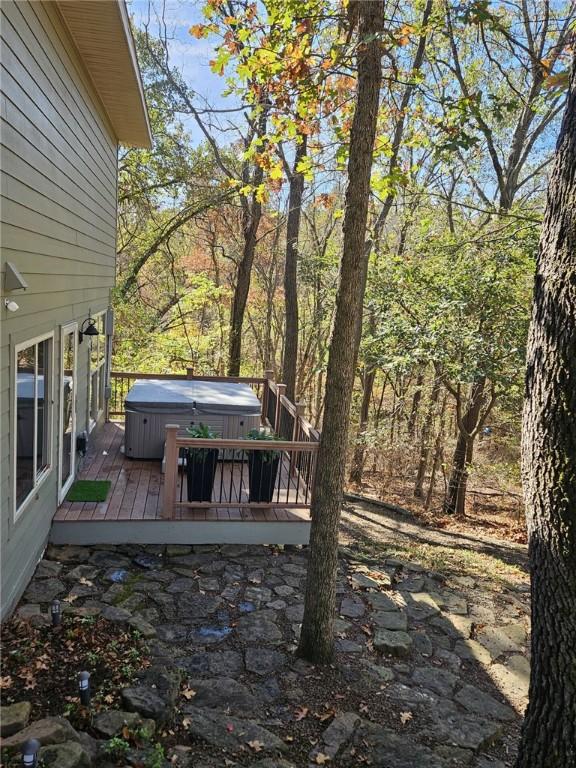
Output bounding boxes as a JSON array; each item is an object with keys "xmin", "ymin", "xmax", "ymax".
[{"xmin": 162, "ymin": 425, "xmax": 318, "ymax": 519}]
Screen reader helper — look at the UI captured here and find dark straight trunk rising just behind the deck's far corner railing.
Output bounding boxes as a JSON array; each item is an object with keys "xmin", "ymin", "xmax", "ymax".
[{"xmin": 282, "ymin": 135, "xmax": 308, "ymax": 402}]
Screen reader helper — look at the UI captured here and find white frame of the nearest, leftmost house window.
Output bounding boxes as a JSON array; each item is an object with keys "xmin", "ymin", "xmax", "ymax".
[{"xmin": 11, "ymin": 331, "xmax": 55, "ymax": 522}]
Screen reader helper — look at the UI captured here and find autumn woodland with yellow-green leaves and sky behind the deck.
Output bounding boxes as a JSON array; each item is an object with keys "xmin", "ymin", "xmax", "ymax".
[{"xmin": 113, "ymin": 0, "xmax": 574, "ymax": 540}]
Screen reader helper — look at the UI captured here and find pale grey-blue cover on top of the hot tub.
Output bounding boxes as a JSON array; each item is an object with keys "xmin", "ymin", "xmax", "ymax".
[{"xmin": 125, "ymin": 379, "xmax": 262, "ymax": 416}]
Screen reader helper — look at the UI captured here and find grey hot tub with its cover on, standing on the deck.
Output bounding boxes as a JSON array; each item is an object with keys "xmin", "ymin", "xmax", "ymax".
[{"xmin": 124, "ymin": 379, "xmax": 261, "ymax": 459}]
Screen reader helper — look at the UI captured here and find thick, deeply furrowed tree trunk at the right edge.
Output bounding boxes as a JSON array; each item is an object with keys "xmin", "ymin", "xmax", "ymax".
[{"xmin": 516, "ymin": 59, "xmax": 576, "ymax": 768}]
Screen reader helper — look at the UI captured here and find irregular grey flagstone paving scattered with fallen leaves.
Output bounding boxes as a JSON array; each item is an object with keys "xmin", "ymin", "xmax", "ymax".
[{"xmin": 4, "ymin": 545, "xmax": 529, "ymax": 768}]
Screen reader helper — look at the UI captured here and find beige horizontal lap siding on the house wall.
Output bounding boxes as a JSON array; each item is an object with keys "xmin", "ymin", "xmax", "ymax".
[{"xmin": 0, "ymin": 0, "xmax": 117, "ymax": 615}]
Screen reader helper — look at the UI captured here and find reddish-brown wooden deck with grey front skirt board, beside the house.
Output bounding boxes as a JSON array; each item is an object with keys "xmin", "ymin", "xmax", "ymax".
[{"xmin": 52, "ymin": 422, "xmax": 310, "ymax": 544}]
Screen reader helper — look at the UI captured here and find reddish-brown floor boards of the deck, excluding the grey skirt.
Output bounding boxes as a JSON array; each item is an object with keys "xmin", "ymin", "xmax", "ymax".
[{"xmin": 54, "ymin": 422, "xmax": 310, "ymax": 523}]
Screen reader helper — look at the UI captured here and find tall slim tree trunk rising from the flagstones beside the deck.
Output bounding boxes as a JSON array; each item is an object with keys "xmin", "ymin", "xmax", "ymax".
[{"xmin": 298, "ymin": 0, "xmax": 384, "ymax": 663}]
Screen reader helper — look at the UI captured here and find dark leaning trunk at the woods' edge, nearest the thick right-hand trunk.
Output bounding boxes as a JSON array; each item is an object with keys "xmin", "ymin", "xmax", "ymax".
[{"xmin": 444, "ymin": 376, "xmax": 487, "ymax": 517}]
